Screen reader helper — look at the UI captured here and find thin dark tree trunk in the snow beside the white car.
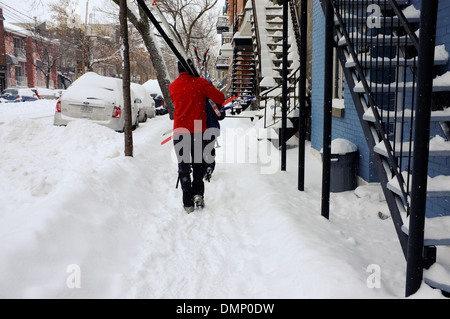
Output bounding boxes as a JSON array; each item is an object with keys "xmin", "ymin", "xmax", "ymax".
[{"xmin": 119, "ymin": 0, "xmax": 133, "ymax": 156}]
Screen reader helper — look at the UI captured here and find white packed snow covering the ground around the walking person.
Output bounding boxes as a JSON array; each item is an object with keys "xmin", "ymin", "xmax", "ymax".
[{"xmin": 0, "ymin": 101, "xmax": 440, "ymax": 298}]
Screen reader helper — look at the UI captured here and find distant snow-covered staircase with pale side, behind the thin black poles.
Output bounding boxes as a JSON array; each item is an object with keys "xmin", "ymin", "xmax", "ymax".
[{"xmin": 248, "ymin": 0, "xmax": 300, "ymax": 146}]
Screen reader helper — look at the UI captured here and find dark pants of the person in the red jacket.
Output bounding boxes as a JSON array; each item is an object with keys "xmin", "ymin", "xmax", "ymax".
[{"xmin": 173, "ymin": 133, "xmax": 206, "ymax": 207}]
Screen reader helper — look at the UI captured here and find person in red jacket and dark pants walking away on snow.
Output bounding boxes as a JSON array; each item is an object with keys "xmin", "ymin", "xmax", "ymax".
[{"xmin": 169, "ymin": 63, "xmax": 225, "ymax": 213}]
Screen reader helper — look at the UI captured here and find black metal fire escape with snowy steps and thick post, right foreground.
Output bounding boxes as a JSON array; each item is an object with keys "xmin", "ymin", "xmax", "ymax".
[{"xmin": 321, "ymin": 0, "xmax": 450, "ymax": 295}]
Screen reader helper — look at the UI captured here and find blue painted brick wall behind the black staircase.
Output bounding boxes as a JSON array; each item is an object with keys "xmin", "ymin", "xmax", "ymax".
[{"xmin": 311, "ymin": 0, "xmax": 450, "ymax": 217}]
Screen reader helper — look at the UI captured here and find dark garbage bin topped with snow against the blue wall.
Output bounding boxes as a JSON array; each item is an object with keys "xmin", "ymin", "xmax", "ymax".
[{"xmin": 322, "ymin": 139, "xmax": 359, "ymax": 193}]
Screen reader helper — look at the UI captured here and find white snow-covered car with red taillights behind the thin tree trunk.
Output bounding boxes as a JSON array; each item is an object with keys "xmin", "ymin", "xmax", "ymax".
[{"xmin": 53, "ymin": 72, "xmax": 139, "ymax": 132}]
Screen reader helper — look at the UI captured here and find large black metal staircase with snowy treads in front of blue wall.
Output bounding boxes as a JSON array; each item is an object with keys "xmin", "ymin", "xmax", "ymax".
[{"xmin": 321, "ymin": 0, "xmax": 450, "ymax": 294}]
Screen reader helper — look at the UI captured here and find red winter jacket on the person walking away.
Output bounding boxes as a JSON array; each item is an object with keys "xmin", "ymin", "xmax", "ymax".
[{"xmin": 169, "ymin": 72, "xmax": 225, "ymax": 133}]
